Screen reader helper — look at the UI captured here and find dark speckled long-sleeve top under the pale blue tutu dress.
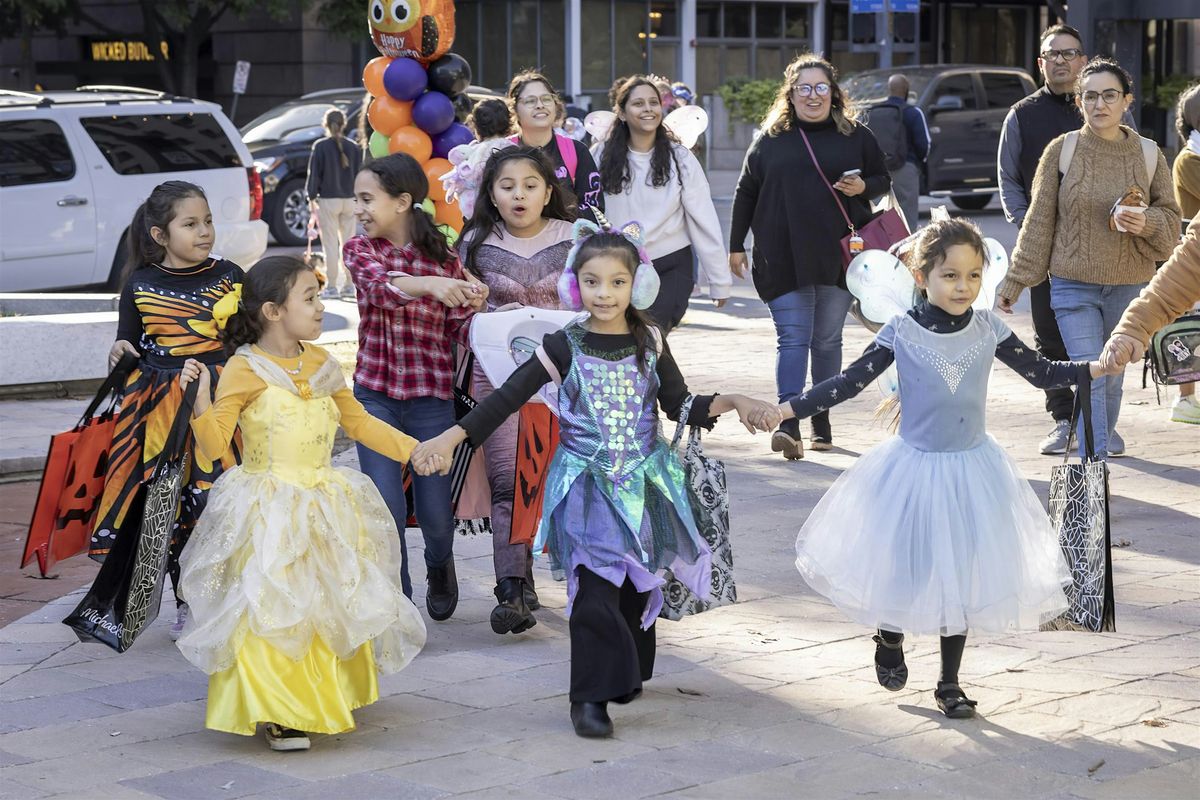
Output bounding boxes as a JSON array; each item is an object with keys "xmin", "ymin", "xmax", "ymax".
[{"xmin": 791, "ymin": 302, "xmax": 1091, "ymax": 419}]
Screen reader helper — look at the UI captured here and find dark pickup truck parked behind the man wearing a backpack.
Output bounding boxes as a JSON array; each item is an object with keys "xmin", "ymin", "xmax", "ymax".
[{"xmin": 842, "ymin": 64, "xmax": 1036, "ymax": 210}]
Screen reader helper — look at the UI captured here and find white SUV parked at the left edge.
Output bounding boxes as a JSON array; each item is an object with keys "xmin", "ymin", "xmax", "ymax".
[{"xmin": 0, "ymin": 86, "xmax": 266, "ymax": 291}]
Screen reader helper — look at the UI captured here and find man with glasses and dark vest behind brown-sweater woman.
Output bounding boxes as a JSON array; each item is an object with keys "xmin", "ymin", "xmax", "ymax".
[{"xmin": 998, "ymin": 25, "xmax": 1136, "ymax": 456}]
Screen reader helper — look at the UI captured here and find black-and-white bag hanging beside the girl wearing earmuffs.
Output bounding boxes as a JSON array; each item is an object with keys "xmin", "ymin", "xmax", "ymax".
[{"xmin": 659, "ymin": 397, "xmax": 738, "ymax": 620}]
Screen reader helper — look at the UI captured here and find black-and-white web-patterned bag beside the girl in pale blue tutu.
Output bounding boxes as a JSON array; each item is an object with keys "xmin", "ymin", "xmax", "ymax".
[{"xmin": 1042, "ymin": 381, "xmax": 1116, "ymax": 632}]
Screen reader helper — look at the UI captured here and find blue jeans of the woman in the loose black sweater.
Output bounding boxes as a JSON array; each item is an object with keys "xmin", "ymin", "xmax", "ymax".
[{"xmin": 767, "ymin": 287, "xmax": 853, "ymax": 403}]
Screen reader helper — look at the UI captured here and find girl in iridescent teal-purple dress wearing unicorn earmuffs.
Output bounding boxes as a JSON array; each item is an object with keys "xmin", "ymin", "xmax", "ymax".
[{"xmin": 413, "ymin": 215, "xmax": 778, "ymax": 736}]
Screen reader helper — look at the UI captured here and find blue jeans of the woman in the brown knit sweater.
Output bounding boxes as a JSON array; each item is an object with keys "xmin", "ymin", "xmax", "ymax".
[{"xmin": 1050, "ymin": 277, "xmax": 1146, "ymax": 458}]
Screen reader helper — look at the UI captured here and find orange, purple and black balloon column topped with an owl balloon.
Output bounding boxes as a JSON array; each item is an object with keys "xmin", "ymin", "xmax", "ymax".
[{"xmin": 362, "ymin": 0, "xmax": 474, "ymax": 231}]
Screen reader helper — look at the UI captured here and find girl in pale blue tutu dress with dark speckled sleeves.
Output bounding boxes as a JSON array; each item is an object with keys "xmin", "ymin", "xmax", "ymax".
[{"xmin": 780, "ymin": 219, "xmax": 1102, "ymax": 717}]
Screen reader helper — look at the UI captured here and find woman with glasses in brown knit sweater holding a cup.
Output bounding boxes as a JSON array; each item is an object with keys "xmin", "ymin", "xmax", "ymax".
[{"xmin": 996, "ymin": 59, "xmax": 1180, "ymax": 457}]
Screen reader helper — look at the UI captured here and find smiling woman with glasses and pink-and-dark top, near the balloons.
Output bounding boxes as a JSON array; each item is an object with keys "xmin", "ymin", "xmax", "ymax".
[{"xmin": 509, "ymin": 70, "xmax": 604, "ymax": 221}]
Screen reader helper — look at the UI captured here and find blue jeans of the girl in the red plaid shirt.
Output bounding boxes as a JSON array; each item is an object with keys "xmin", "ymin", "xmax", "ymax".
[{"xmin": 354, "ymin": 384, "xmax": 455, "ymax": 600}]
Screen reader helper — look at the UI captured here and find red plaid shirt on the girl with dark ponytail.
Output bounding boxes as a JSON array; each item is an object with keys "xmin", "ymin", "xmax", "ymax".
[{"xmin": 342, "ymin": 236, "xmax": 475, "ymax": 399}]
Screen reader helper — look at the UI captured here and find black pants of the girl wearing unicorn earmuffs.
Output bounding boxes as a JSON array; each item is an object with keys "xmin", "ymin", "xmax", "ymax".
[{"xmin": 570, "ymin": 567, "xmax": 655, "ymax": 703}]
